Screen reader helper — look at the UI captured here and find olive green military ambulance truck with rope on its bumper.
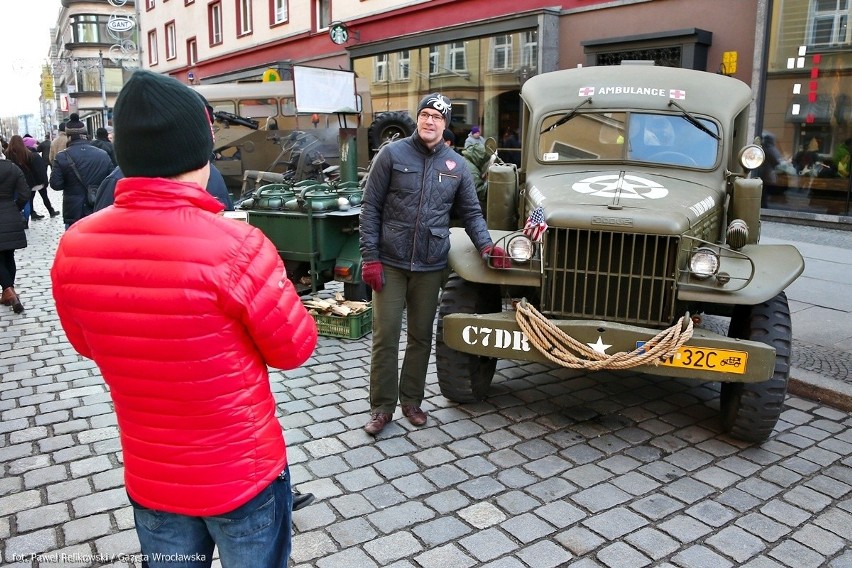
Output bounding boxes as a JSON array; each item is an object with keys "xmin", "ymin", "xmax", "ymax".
[{"xmin": 436, "ymin": 64, "xmax": 804, "ymax": 441}]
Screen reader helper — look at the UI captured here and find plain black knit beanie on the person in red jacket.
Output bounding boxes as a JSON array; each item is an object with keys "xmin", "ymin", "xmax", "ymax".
[{"xmin": 112, "ymin": 70, "xmax": 213, "ymax": 177}]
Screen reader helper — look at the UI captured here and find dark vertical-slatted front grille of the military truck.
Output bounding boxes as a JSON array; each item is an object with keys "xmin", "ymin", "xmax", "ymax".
[{"xmin": 542, "ymin": 228, "xmax": 679, "ymax": 327}]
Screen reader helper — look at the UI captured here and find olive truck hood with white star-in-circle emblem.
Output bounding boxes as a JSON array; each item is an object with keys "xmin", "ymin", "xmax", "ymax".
[{"xmin": 526, "ymin": 168, "xmax": 725, "ymax": 234}]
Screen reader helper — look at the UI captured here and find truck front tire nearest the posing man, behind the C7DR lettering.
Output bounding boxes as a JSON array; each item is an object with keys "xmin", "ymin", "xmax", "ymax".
[{"xmin": 435, "ymin": 272, "xmax": 501, "ymax": 402}]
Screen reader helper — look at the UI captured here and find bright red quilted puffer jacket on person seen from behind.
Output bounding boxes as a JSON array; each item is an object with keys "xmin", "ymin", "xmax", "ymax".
[{"xmin": 51, "ymin": 178, "xmax": 317, "ymax": 516}]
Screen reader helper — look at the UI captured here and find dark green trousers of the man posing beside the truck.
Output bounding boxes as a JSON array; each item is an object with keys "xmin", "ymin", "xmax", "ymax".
[{"xmin": 370, "ymin": 265, "xmax": 444, "ymax": 415}]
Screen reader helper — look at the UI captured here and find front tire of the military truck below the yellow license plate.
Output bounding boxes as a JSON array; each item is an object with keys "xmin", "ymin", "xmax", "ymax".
[{"xmin": 719, "ymin": 292, "xmax": 793, "ymax": 442}]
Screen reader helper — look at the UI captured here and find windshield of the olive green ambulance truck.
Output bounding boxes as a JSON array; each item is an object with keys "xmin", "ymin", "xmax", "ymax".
[{"xmin": 538, "ymin": 112, "xmax": 719, "ymax": 169}]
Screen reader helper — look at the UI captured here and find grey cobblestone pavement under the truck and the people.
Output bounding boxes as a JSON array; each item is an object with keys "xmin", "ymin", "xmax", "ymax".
[{"xmin": 0, "ymin": 215, "xmax": 852, "ymax": 568}]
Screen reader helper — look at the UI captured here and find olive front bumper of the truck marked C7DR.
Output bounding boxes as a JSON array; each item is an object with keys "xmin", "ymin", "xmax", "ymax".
[{"xmin": 443, "ymin": 311, "xmax": 775, "ymax": 383}]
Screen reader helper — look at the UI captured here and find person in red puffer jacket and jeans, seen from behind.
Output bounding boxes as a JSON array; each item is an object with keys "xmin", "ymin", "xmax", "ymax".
[{"xmin": 51, "ymin": 70, "xmax": 317, "ymax": 568}]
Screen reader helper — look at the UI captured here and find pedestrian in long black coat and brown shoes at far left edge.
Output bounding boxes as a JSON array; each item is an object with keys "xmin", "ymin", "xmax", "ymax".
[{"xmin": 0, "ymin": 149, "xmax": 30, "ymax": 314}]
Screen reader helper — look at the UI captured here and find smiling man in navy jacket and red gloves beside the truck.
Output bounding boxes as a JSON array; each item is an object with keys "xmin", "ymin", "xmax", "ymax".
[{"xmin": 360, "ymin": 93, "xmax": 510, "ymax": 436}]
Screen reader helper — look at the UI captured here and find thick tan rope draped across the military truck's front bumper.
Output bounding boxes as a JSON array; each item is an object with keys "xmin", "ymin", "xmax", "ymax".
[{"xmin": 515, "ymin": 299, "xmax": 693, "ymax": 371}]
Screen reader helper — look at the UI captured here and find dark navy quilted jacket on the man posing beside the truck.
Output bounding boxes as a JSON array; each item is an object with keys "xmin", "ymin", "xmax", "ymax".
[{"xmin": 360, "ymin": 132, "xmax": 491, "ymax": 272}]
